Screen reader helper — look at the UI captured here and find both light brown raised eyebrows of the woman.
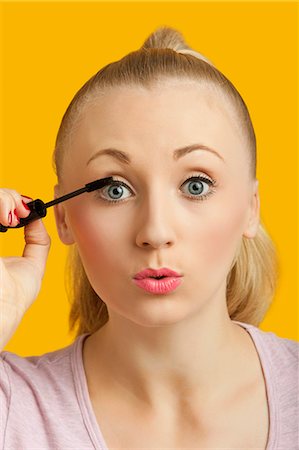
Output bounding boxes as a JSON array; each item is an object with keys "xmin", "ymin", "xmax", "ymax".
[{"xmin": 87, "ymin": 144, "xmax": 225, "ymax": 165}]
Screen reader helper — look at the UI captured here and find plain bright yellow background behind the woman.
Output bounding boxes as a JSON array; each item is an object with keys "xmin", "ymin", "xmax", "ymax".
[{"xmin": 0, "ymin": 2, "xmax": 298, "ymax": 356}]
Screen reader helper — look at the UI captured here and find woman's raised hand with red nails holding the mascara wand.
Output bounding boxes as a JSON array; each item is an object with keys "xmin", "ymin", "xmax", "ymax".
[{"xmin": 0, "ymin": 189, "xmax": 51, "ymax": 351}]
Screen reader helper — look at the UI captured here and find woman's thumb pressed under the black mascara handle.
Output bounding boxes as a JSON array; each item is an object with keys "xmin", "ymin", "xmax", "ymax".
[{"xmin": 23, "ymin": 219, "xmax": 51, "ymax": 276}]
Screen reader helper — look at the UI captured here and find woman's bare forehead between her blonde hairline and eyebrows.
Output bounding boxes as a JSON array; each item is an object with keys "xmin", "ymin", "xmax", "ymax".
[{"xmin": 72, "ymin": 80, "xmax": 244, "ymax": 165}]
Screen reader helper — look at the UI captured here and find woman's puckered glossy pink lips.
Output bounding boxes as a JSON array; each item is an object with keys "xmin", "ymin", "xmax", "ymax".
[{"xmin": 133, "ymin": 268, "xmax": 182, "ymax": 294}]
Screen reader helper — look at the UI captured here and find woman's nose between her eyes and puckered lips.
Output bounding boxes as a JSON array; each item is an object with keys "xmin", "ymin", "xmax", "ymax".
[{"xmin": 136, "ymin": 193, "xmax": 176, "ymax": 249}]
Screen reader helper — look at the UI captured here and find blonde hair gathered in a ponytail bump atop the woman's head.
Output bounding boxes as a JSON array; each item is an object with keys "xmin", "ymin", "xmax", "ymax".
[{"xmin": 141, "ymin": 26, "xmax": 215, "ymax": 67}]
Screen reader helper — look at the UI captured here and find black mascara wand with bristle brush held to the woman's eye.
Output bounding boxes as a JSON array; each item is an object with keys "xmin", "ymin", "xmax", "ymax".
[{"xmin": 0, "ymin": 177, "xmax": 113, "ymax": 233}]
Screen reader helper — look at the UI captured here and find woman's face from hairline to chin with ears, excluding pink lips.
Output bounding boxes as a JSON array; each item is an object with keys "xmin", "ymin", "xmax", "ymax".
[{"xmin": 56, "ymin": 81, "xmax": 259, "ymax": 326}]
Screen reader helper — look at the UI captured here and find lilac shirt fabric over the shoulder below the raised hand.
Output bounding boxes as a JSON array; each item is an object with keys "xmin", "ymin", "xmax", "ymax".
[{"xmin": 0, "ymin": 336, "xmax": 91, "ymax": 449}]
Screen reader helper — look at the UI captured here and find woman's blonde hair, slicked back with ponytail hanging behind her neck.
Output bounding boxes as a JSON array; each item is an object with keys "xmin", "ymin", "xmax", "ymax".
[{"xmin": 53, "ymin": 27, "xmax": 278, "ymax": 336}]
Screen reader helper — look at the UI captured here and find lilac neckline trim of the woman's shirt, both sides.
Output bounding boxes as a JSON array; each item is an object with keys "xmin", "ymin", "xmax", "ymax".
[{"xmin": 71, "ymin": 320, "xmax": 279, "ymax": 450}]
